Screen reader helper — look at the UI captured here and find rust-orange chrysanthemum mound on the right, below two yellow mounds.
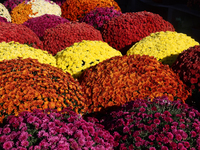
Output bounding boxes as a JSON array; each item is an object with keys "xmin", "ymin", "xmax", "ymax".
[{"xmin": 79, "ymin": 54, "xmax": 190, "ymax": 112}]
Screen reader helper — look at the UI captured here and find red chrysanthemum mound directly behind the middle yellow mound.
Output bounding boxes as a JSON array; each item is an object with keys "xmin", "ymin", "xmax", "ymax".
[{"xmin": 43, "ymin": 22, "xmax": 103, "ymax": 55}]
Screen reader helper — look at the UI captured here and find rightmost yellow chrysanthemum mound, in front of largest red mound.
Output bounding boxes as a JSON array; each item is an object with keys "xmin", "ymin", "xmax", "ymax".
[{"xmin": 127, "ymin": 31, "xmax": 199, "ymax": 66}]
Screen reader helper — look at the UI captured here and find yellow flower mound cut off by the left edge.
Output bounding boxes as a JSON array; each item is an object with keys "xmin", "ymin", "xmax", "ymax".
[{"xmin": 0, "ymin": 41, "xmax": 57, "ymax": 67}]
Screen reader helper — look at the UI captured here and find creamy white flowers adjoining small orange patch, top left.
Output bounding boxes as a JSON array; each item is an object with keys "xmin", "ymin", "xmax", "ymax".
[{"xmin": 27, "ymin": 0, "xmax": 61, "ymax": 18}]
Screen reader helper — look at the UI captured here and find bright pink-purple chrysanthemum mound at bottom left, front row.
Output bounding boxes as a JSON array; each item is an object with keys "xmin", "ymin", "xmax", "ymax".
[{"xmin": 0, "ymin": 108, "xmax": 114, "ymax": 150}]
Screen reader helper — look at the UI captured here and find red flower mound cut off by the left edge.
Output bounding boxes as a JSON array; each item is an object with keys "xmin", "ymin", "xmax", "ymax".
[{"xmin": 0, "ymin": 22, "xmax": 43, "ymax": 49}]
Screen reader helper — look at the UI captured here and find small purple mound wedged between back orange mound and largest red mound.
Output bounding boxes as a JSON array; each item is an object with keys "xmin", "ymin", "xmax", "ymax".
[{"xmin": 79, "ymin": 7, "xmax": 122, "ymax": 30}]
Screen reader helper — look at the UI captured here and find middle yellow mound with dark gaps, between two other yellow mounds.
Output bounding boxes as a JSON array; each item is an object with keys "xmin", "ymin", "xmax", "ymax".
[{"xmin": 55, "ymin": 40, "xmax": 122, "ymax": 78}]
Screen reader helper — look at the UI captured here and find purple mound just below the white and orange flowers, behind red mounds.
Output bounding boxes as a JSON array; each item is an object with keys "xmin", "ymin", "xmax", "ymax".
[{"xmin": 23, "ymin": 14, "xmax": 70, "ymax": 40}]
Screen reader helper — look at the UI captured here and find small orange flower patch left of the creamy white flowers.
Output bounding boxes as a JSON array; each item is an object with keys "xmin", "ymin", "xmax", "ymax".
[{"xmin": 11, "ymin": 1, "xmax": 34, "ymax": 24}]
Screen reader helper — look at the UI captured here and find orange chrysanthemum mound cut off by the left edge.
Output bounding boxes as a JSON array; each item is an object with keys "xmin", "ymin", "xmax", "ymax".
[{"xmin": 0, "ymin": 58, "xmax": 86, "ymax": 122}]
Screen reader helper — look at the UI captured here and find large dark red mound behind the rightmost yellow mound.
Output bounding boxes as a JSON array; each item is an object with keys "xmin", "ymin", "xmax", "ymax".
[{"xmin": 101, "ymin": 11, "xmax": 175, "ymax": 54}]
